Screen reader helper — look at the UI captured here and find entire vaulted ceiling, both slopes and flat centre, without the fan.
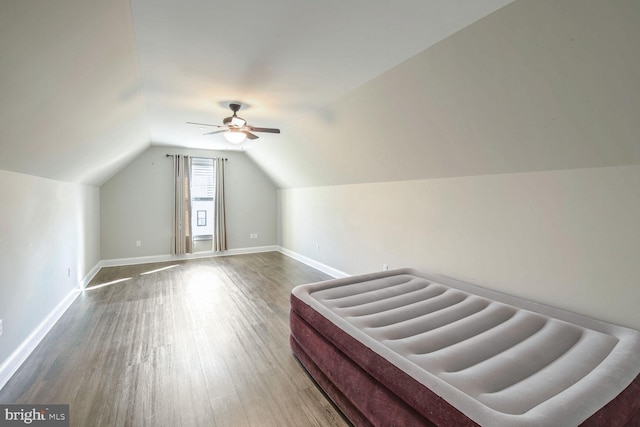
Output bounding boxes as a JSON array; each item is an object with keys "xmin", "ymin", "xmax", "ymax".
[{"xmin": 0, "ymin": 0, "xmax": 640, "ymax": 187}]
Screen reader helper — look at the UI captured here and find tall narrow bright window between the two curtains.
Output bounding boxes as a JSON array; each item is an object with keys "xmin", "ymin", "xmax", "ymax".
[{"xmin": 190, "ymin": 157, "xmax": 215, "ymax": 240}]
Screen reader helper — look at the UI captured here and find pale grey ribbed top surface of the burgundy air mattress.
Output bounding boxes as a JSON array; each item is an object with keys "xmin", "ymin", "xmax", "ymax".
[{"xmin": 293, "ymin": 269, "xmax": 640, "ymax": 426}]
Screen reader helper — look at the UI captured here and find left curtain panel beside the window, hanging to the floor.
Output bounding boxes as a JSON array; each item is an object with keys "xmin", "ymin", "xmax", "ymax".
[{"xmin": 171, "ymin": 154, "xmax": 193, "ymax": 255}]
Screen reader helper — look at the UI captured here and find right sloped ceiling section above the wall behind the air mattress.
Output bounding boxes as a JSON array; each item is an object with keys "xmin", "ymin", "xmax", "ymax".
[{"xmin": 255, "ymin": 0, "xmax": 640, "ymax": 187}]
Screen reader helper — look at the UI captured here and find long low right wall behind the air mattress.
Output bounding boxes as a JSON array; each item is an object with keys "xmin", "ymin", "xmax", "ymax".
[{"xmin": 279, "ymin": 166, "xmax": 640, "ymax": 329}]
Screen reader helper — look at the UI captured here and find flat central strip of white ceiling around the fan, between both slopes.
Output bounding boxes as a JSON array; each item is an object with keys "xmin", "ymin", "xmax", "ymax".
[{"xmin": 132, "ymin": 0, "xmax": 510, "ymax": 154}]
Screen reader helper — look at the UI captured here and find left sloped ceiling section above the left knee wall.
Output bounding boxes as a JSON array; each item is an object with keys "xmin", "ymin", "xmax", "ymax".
[{"xmin": 0, "ymin": 0, "xmax": 149, "ymax": 184}]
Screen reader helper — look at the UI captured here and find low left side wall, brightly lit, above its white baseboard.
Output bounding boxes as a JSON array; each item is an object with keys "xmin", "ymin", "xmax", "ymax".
[{"xmin": 0, "ymin": 170, "xmax": 100, "ymax": 366}]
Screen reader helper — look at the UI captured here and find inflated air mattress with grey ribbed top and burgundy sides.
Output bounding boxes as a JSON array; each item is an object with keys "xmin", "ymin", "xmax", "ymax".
[{"xmin": 290, "ymin": 269, "xmax": 640, "ymax": 427}]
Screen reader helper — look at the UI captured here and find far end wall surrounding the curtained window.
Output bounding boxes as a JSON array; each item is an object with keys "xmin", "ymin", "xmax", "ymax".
[{"xmin": 100, "ymin": 147, "xmax": 277, "ymax": 260}]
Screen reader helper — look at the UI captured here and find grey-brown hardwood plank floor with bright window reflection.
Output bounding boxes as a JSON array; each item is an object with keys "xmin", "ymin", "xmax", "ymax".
[{"xmin": 0, "ymin": 252, "xmax": 348, "ymax": 426}]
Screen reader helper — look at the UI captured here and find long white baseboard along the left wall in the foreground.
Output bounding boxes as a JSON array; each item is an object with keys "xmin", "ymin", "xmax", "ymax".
[{"xmin": 0, "ymin": 289, "xmax": 81, "ymax": 390}]
